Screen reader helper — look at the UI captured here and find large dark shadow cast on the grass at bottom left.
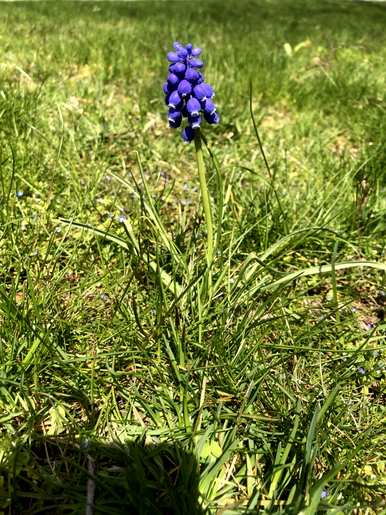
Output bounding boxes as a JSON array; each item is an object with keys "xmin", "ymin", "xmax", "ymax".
[{"xmin": 0, "ymin": 437, "xmax": 204, "ymax": 515}]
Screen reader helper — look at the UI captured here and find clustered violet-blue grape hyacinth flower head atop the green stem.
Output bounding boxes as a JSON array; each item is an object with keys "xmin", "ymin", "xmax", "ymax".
[{"xmin": 162, "ymin": 41, "xmax": 220, "ymax": 142}]
